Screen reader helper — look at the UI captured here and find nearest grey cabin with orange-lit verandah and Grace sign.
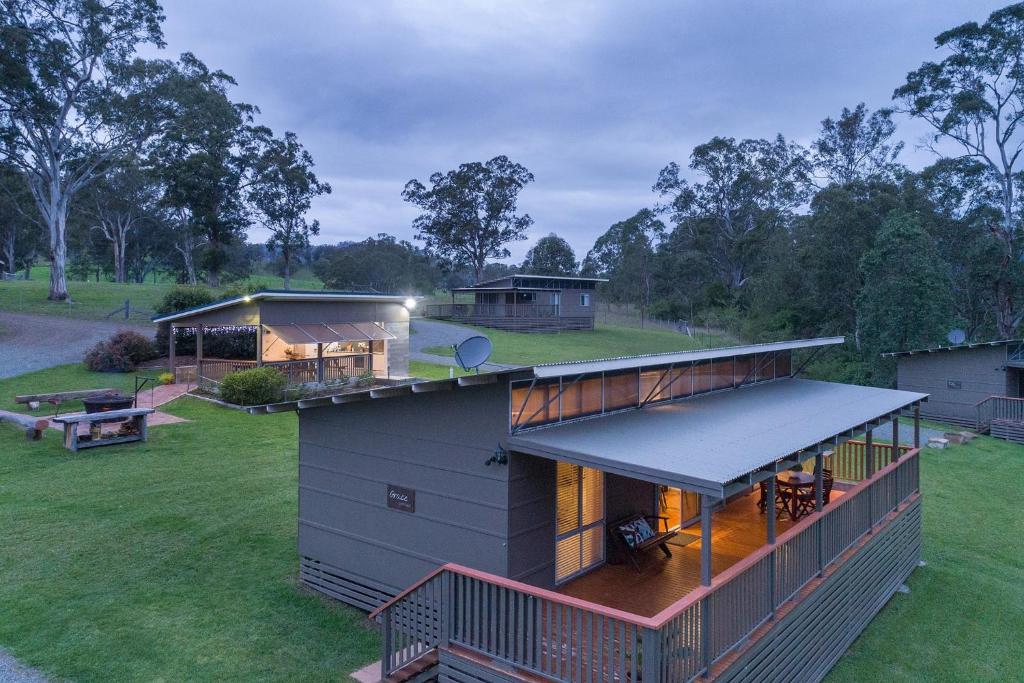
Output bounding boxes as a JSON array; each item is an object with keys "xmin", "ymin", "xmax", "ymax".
[{"xmin": 252, "ymin": 338, "xmax": 927, "ymax": 683}]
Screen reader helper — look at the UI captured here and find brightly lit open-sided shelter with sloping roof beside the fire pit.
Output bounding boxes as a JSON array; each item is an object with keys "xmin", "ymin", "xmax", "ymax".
[{"xmin": 154, "ymin": 290, "xmax": 415, "ymax": 384}]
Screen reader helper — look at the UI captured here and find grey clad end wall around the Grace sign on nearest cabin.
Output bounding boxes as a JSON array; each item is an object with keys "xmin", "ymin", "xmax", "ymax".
[{"xmin": 299, "ymin": 383, "xmax": 509, "ymax": 606}]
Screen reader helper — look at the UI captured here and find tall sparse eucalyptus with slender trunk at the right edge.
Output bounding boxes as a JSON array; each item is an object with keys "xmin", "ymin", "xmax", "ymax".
[{"xmin": 893, "ymin": 3, "xmax": 1024, "ymax": 337}]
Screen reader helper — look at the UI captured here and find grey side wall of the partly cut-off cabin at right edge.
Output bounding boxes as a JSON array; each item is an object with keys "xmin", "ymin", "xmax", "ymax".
[{"xmin": 896, "ymin": 346, "xmax": 1016, "ymax": 424}]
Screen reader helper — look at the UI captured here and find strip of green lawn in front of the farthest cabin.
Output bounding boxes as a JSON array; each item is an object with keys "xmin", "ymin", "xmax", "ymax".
[{"xmin": 424, "ymin": 325, "xmax": 735, "ymax": 366}]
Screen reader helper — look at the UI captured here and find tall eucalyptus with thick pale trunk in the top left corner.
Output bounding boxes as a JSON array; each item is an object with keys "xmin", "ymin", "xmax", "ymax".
[{"xmin": 0, "ymin": 0, "xmax": 164, "ymax": 300}]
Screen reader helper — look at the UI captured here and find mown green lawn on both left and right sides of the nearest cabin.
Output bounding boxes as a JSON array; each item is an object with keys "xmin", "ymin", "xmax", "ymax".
[{"xmin": 0, "ymin": 366, "xmax": 1024, "ymax": 683}]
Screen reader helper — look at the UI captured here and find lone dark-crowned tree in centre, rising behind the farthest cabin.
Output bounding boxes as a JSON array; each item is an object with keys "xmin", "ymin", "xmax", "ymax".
[{"xmin": 401, "ymin": 155, "xmax": 534, "ymax": 281}]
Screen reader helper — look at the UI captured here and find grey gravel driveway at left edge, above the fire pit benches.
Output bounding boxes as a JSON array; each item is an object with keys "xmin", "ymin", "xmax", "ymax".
[{"xmin": 0, "ymin": 311, "xmax": 154, "ymax": 377}]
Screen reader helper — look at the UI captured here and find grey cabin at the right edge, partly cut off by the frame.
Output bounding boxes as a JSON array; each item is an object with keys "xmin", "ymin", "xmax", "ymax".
[{"xmin": 883, "ymin": 339, "xmax": 1024, "ymax": 442}]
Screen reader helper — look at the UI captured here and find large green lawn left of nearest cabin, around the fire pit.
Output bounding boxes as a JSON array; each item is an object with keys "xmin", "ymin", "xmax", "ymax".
[{"xmin": 0, "ymin": 362, "xmax": 379, "ymax": 681}]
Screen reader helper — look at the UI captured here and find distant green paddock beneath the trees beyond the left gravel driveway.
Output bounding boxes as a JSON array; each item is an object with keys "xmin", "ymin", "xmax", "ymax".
[{"xmin": 0, "ymin": 266, "xmax": 324, "ymax": 323}]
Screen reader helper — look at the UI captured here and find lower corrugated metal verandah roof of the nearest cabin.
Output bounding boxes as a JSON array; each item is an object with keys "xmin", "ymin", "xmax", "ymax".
[{"xmin": 508, "ymin": 379, "xmax": 928, "ymax": 496}]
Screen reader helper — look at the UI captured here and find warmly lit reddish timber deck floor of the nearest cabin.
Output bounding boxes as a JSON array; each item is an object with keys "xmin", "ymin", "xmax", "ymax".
[{"xmin": 557, "ymin": 484, "xmax": 843, "ymax": 616}]
